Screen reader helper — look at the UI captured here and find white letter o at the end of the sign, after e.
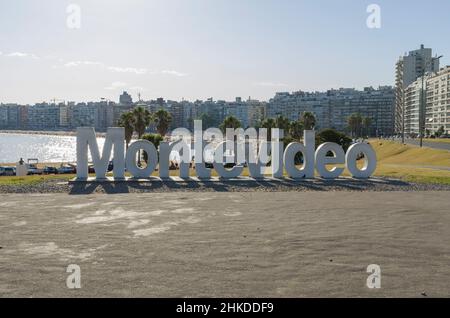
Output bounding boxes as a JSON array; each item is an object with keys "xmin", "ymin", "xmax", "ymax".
[{"xmin": 345, "ymin": 143, "xmax": 377, "ymax": 179}]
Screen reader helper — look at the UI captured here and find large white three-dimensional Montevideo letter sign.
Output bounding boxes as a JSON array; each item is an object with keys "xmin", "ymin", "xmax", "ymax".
[{"xmin": 76, "ymin": 121, "xmax": 377, "ymax": 181}]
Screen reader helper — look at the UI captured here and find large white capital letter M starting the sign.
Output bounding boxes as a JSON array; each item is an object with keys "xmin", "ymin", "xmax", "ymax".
[{"xmin": 77, "ymin": 127, "xmax": 125, "ymax": 180}]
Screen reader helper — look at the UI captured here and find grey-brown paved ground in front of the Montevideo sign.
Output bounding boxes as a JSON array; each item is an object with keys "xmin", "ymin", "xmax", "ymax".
[{"xmin": 0, "ymin": 191, "xmax": 450, "ymax": 297}]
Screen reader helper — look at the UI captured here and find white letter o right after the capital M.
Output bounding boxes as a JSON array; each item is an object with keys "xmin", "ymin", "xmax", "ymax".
[{"xmin": 125, "ymin": 140, "xmax": 158, "ymax": 178}]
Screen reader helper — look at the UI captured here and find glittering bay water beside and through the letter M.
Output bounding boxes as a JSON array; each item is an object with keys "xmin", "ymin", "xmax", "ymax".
[{"xmin": 0, "ymin": 133, "xmax": 104, "ymax": 163}]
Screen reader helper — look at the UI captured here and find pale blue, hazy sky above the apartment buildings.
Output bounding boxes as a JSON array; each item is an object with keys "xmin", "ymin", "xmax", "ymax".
[{"xmin": 0, "ymin": 0, "xmax": 450, "ymax": 104}]
